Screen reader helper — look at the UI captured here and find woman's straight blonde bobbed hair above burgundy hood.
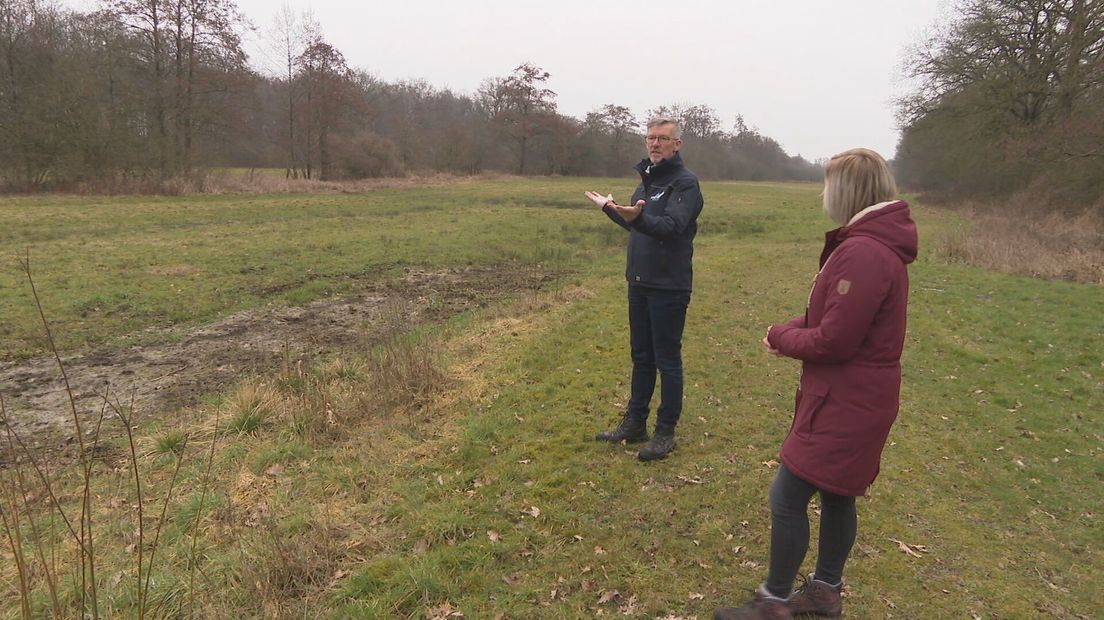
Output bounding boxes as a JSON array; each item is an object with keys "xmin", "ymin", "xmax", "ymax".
[{"xmin": 825, "ymin": 149, "xmax": 896, "ymax": 226}]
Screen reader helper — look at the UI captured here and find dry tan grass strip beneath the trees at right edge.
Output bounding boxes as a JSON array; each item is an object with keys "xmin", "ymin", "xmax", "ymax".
[{"xmin": 935, "ymin": 200, "xmax": 1104, "ymax": 285}]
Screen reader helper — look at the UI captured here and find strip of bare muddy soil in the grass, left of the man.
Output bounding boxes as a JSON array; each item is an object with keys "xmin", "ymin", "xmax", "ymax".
[{"xmin": 0, "ymin": 266, "xmax": 555, "ymax": 446}]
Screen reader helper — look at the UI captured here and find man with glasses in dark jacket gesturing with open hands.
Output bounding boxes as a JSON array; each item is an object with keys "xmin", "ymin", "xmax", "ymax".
[{"xmin": 586, "ymin": 117, "xmax": 704, "ymax": 461}]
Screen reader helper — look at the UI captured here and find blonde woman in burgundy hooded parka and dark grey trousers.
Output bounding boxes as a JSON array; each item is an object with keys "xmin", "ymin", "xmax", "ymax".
[{"xmin": 713, "ymin": 149, "xmax": 916, "ymax": 620}]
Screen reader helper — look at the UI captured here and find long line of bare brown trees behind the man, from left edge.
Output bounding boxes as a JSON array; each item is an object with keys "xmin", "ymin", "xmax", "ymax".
[{"xmin": 0, "ymin": 0, "xmax": 820, "ymax": 191}]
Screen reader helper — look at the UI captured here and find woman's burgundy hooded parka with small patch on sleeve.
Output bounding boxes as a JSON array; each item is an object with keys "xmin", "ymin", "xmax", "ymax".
[{"xmin": 767, "ymin": 201, "xmax": 917, "ymax": 495}]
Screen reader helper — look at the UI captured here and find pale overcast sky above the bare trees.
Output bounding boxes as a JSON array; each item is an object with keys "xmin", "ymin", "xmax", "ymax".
[{"xmin": 66, "ymin": 0, "xmax": 948, "ymax": 160}]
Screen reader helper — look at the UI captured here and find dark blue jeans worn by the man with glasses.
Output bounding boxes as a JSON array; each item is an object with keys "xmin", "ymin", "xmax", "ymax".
[{"xmin": 627, "ymin": 285, "xmax": 690, "ymax": 428}]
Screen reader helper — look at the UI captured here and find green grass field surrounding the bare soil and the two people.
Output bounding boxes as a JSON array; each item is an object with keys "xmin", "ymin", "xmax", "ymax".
[{"xmin": 0, "ymin": 179, "xmax": 1104, "ymax": 619}]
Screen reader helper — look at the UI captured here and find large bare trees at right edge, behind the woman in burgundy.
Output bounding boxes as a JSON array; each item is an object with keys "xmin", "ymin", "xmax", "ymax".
[{"xmin": 895, "ymin": 0, "xmax": 1104, "ymax": 211}]
